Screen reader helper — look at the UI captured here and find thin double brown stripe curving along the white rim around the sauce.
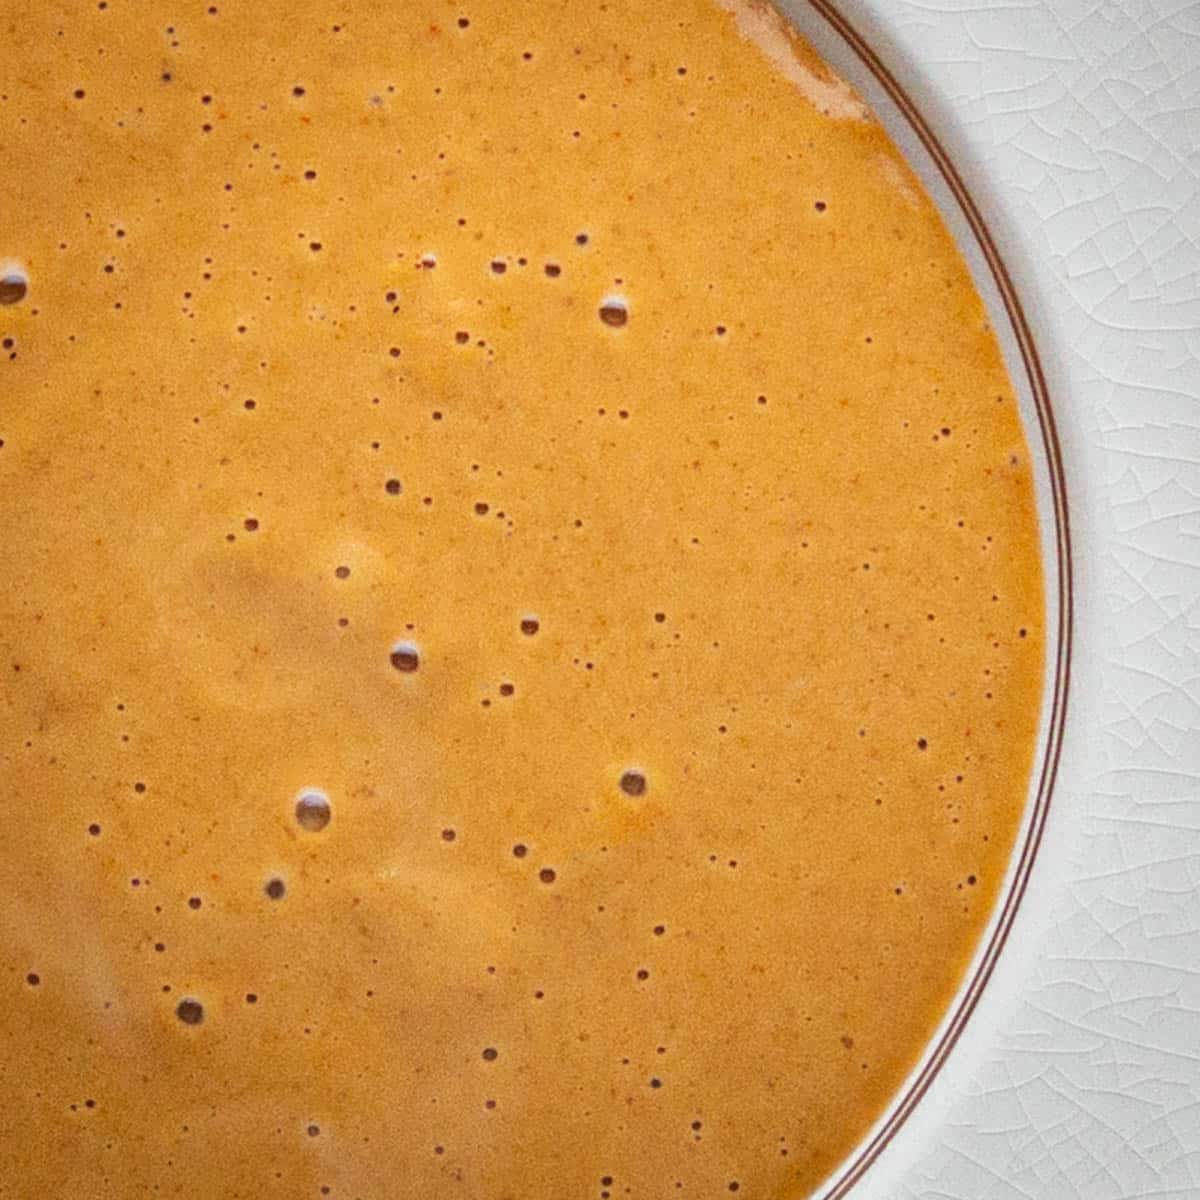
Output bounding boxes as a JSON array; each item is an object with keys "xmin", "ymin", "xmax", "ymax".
[{"xmin": 808, "ymin": 0, "xmax": 1073, "ymax": 1200}]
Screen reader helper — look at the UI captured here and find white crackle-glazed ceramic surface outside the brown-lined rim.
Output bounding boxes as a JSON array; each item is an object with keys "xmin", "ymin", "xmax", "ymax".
[{"xmin": 816, "ymin": 0, "xmax": 1200, "ymax": 1200}]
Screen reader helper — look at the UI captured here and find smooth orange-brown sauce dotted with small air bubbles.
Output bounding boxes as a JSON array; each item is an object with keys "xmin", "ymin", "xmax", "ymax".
[{"xmin": 0, "ymin": 0, "xmax": 1043, "ymax": 1200}]
